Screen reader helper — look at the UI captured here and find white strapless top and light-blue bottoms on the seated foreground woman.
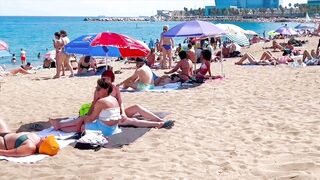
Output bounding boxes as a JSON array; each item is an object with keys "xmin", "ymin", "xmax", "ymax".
[{"xmin": 85, "ymin": 107, "xmax": 122, "ymax": 136}]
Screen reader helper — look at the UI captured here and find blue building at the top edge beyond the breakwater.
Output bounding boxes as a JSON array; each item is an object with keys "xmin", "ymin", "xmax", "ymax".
[{"xmin": 215, "ymin": 0, "xmax": 283, "ymax": 9}]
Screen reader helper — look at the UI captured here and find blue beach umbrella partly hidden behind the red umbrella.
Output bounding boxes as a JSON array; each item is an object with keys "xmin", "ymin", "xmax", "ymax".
[{"xmin": 65, "ymin": 34, "xmax": 121, "ymax": 57}]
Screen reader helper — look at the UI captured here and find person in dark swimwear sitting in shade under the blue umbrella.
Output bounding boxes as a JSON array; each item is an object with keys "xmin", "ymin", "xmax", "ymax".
[{"xmin": 77, "ymin": 56, "xmax": 96, "ymax": 75}]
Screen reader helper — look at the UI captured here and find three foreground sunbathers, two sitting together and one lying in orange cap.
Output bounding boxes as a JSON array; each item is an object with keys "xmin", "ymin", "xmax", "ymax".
[{"xmin": 0, "ymin": 63, "xmax": 178, "ymax": 157}]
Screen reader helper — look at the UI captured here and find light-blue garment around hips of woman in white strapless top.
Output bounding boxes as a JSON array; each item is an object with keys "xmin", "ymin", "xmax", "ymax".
[{"xmin": 85, "ymin": 120, "xmax": 121, "ymax": 136}]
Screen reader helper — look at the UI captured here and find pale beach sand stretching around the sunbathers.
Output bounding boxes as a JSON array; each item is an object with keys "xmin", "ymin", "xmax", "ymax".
[{"xmin": 0, "ymin": 38, "xmax": 320, "ymax": 180}]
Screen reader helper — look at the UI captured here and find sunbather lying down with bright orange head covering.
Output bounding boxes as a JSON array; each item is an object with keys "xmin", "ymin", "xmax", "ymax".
[{"xmin": 0, "ymin": 119, "xmax": 59, "ymax": 157}]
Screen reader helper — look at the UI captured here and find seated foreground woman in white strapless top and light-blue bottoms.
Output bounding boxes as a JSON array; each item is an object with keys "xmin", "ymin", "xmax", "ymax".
[{"xmin": 49, "ymin": 79, "xmax": 122, "ymax": 136}]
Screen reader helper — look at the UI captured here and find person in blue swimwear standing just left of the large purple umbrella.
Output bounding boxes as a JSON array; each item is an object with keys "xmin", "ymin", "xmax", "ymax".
[{"xmin": 160, "ymin": 25, "xmax": 174, "ymax": 69}]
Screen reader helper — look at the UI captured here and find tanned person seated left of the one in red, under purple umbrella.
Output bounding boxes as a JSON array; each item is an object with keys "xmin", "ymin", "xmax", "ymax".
[{"xmin": 164, "ymin": 51, "xmax": 193, "ymax": 82}]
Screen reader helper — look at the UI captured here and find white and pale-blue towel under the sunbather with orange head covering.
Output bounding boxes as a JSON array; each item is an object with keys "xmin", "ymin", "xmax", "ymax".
[{"xmin": 0, "ymin": 127, "xmax": 76, "ymax": 163}]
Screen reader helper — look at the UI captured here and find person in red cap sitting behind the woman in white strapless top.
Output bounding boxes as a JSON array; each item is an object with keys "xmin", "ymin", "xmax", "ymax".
[{"xmin": 96, "ymin": 67, "xmax": 173, "ymax": 128}]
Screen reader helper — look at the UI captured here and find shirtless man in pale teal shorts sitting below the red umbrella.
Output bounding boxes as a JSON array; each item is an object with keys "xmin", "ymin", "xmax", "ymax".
[{"xmin": 117, "ymin": 58, "xmax": 154, "ymax": 91}]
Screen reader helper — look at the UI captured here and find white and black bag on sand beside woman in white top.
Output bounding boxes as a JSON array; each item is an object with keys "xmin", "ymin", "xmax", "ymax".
[{"xmin": 74, "ymin": 130, "xmax": 108, "ymax": 151}]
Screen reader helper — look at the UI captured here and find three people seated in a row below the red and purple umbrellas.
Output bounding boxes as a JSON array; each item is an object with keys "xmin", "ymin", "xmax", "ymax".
[{"xmin": 118, "ymin": 50, "xmax": 212, "ymax": 91}]
